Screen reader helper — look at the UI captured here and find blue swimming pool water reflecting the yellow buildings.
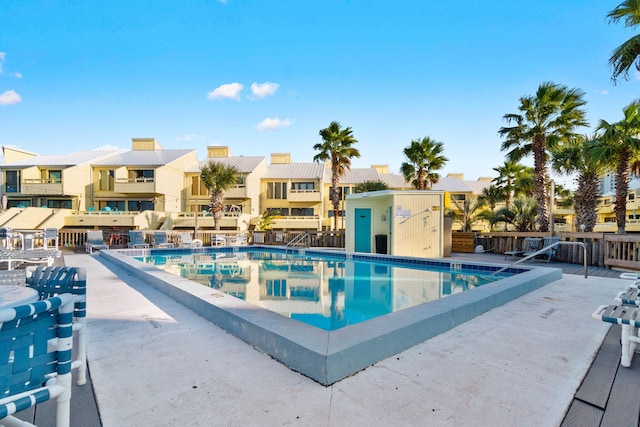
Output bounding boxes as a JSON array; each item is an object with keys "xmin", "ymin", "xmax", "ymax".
[{"xmin": 135, "ymin": 248, "xmax": 518, "ymax": 331}]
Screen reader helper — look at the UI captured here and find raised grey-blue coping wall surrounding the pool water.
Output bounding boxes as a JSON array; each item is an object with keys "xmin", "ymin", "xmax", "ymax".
[{"xmin": 100, "ymin": 246, "xmax": 562, "ymax": 386}]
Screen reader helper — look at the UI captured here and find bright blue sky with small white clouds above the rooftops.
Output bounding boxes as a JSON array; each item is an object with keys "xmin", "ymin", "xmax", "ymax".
[{"xmin": 0, "ymin": 0, "xmax": 640, "ymax": 187}]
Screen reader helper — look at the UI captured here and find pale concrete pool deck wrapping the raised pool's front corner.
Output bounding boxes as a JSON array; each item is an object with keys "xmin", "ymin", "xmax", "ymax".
[{"xmin": 65, "ymin": 255, "xmax": 628, "ymax": 426}]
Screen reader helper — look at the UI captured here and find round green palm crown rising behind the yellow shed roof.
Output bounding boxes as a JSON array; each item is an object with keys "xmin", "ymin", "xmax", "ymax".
[{"xmin": 400, "ymin": 136, "xmax": 449, "ymax": 190}]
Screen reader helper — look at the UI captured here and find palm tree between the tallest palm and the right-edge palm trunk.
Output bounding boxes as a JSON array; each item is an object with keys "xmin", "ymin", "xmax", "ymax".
[{"xmin": 551, "ymin": 135, "xmax": 604, "ymax": 231}]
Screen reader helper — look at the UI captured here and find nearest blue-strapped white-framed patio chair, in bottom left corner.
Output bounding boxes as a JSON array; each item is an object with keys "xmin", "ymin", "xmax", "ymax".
[{"xmin": 0, "ymin": 294, "xmax": 73, "ymax": 427}]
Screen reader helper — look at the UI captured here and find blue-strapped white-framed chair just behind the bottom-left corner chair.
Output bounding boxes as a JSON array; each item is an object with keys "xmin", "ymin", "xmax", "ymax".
[{"xmin": 25, "ymin": 266, "xmax": 87, "ymax": 385}]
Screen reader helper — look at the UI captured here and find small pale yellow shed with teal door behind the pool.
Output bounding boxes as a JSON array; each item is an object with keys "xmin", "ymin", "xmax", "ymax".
[{"xmin": 345, "ymin": 190, "xmax": 444, "ymax": 258}]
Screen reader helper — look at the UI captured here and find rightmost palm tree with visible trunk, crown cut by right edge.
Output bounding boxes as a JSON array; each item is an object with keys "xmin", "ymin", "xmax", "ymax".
[{"xmin": 589, "ymin": 100, "xmax": 640, "ymax": 234}]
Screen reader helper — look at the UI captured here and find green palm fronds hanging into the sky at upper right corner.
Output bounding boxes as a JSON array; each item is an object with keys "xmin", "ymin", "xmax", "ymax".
[{"xmin": 607, "ymin": 0, "xmax": 640, "ymax": 83}]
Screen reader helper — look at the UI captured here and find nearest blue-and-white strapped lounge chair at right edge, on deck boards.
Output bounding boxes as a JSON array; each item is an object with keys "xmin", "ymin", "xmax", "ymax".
[{"xmin": 591, "ymin": 305, "xmax": 640, "ymax": 368}]
